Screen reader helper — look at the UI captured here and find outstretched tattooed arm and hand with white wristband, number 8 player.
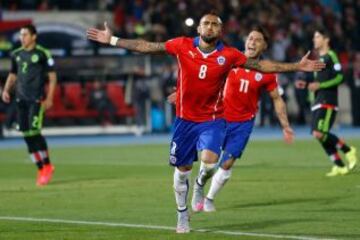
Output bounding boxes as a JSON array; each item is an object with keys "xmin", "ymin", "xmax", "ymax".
[{"xmin": 86, "ymin": 22, "xmax": 166, "ymax": 53}]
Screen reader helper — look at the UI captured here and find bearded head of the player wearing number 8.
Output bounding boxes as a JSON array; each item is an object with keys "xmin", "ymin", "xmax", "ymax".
[{"xmin": 198, "ymin": 15, "xmax": 222, "ymax": 43}]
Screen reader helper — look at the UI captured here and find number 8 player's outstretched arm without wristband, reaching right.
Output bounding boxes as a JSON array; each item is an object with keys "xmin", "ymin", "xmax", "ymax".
[{"xmin": 244, "ymin": 51, "xmax": 326, "ymax": 72}]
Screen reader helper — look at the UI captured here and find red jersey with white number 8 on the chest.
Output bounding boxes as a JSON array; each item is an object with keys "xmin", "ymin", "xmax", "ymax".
[{"xmin": 165, "ymin": 37, "xmax": 246, "ymax": 122}]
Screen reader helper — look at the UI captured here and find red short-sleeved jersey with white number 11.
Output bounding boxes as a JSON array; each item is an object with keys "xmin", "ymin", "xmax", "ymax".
[{"xmin": 224, "ymin": 68, "xmax": 278, "ymax": 122}]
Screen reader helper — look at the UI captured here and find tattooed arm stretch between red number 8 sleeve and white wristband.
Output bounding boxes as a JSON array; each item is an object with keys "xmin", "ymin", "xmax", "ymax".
[{"xmin": 117, "ymin": 38, "xmax": 166, "ymax": 53}]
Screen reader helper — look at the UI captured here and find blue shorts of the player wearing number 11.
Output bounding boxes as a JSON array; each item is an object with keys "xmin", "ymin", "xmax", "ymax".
[{"xmin": 220, "ymin": 119, "xmax": 255, "ymax": 164}]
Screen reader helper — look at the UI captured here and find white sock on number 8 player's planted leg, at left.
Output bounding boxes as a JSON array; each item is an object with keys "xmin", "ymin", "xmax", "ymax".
[{"xmin": 174, "ymin": 168, "xmax": 191, "ymax": 211}]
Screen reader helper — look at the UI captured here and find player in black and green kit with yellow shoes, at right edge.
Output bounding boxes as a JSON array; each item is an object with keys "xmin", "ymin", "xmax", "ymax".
[{"xmin": 296, "ymin": 29, "xmax": 358, "ymax": 177}]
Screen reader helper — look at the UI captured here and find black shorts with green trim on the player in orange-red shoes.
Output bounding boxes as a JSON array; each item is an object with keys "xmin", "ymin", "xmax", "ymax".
[{"xmin": 16, "ymin": 100, "xmax": 44, "ymax": 132}]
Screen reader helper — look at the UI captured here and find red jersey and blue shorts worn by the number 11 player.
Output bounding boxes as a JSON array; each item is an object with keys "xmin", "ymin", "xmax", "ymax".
[{"xmin": 220, "ymin": 68, "xmax": 278, "ymax": 163}]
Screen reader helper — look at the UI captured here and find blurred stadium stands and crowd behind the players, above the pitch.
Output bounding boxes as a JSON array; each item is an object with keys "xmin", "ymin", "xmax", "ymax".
[{"xmin": 0, "ymin": 0, "xmax": 360, "ymax": 136}]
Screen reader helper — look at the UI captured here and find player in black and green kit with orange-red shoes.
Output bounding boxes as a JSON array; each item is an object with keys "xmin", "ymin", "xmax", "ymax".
[{"xmin": 2, "ymin": 25, "xmax": 57, "ymax": 186}]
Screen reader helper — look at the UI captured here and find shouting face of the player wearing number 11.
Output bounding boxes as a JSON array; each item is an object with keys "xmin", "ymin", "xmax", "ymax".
[{"xmin": 245, "ymin": 31, "xmax": 267, "ymax": 58}]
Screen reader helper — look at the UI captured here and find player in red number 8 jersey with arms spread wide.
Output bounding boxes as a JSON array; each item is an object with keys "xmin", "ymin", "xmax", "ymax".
[{"xmin": 87, "ymin": 13, "xmax": 325, "ymax": 233}]
